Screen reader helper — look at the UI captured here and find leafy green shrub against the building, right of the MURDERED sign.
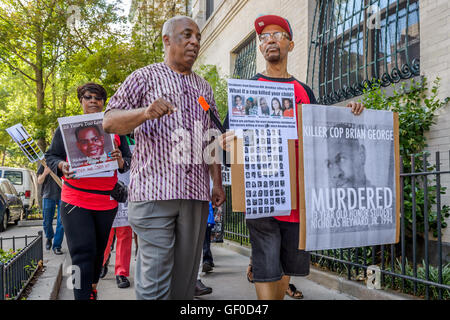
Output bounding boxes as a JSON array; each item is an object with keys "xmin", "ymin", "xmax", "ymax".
[{"xmin": 362, "ymin": 78, "xmax": 450, "ymax": 236}]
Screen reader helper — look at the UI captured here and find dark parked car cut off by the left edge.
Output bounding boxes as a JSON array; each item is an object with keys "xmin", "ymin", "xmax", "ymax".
[{"xmin": 0, "ymin": 178, "xmax": 24, "ymax": 229}]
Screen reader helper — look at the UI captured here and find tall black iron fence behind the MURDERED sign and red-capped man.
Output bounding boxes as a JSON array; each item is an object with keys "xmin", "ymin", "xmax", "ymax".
[{"xmin": 224, "ymin": 151, "xmax": 450, "ymax": 300}]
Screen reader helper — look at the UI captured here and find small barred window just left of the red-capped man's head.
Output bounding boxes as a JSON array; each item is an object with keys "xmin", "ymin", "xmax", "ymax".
[{"xmin": 233, "ymin": 34, "xmax": 256, "ymax": 79}]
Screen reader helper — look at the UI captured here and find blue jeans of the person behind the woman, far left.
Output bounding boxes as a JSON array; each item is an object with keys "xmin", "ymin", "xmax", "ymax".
[{"xmin": 42, "ymin": 198, "xmax": 64, "ymax": 249}]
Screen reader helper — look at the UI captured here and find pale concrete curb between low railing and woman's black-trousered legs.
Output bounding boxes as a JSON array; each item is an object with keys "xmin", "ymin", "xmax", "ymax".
[{"xmin": 27, "ymin": 253, "xmax": 67, "ymax": 300}]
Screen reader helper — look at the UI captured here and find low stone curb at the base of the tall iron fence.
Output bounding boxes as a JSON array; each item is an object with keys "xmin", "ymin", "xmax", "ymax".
[{"xmin": 214, "ymin": 240, "xmax": 422, "ymax": 300}]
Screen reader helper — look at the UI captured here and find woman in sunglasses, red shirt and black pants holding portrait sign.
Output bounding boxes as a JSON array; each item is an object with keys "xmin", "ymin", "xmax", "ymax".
[{"xmin": 45, "ymin": 83, "xmax": 131, "ymax": 300}]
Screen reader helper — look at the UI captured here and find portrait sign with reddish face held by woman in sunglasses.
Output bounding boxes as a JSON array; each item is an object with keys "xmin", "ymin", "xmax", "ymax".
[{"xmin": 58, "ymin": 113, "xmax": 118, "ymax": 177}]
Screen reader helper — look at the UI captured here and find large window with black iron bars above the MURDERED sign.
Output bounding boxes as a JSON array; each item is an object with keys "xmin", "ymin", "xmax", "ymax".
[{"xmin": 308, "ymin": 0, "xmax": 420, "ymax": 104}]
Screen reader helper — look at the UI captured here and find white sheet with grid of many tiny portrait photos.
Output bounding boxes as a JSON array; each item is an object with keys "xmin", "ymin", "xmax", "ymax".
[{"xmin": 244, "ymin": 129, "xmax": 290, "ymax": 216}]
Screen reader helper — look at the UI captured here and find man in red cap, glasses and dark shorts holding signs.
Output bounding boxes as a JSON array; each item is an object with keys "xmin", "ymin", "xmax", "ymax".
[{"xmin": 222, "ymin": 15, "xmax": 364, "ymax": 300}]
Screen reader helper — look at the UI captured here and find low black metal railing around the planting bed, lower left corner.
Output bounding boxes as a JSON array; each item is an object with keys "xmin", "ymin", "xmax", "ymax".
[{"xmin": 0, "ymin": 231, "xmax": 43, "ymax": 300}]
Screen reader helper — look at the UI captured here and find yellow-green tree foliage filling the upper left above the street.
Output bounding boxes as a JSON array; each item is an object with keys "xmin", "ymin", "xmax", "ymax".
[{"xmin": 0, "ymin": 0, "xmax": 187, "ymax": 170}]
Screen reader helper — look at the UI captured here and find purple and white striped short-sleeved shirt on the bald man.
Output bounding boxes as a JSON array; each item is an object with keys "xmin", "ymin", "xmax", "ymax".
[{"xmin": 106, "ymin": 63, "xmax": 218, "ymax": 201}]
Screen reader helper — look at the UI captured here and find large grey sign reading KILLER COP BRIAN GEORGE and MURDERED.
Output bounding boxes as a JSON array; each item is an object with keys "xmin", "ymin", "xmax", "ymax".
[{"xmin": 300, "ymin": 105, "xmax": 400, "ymax": 251}]
